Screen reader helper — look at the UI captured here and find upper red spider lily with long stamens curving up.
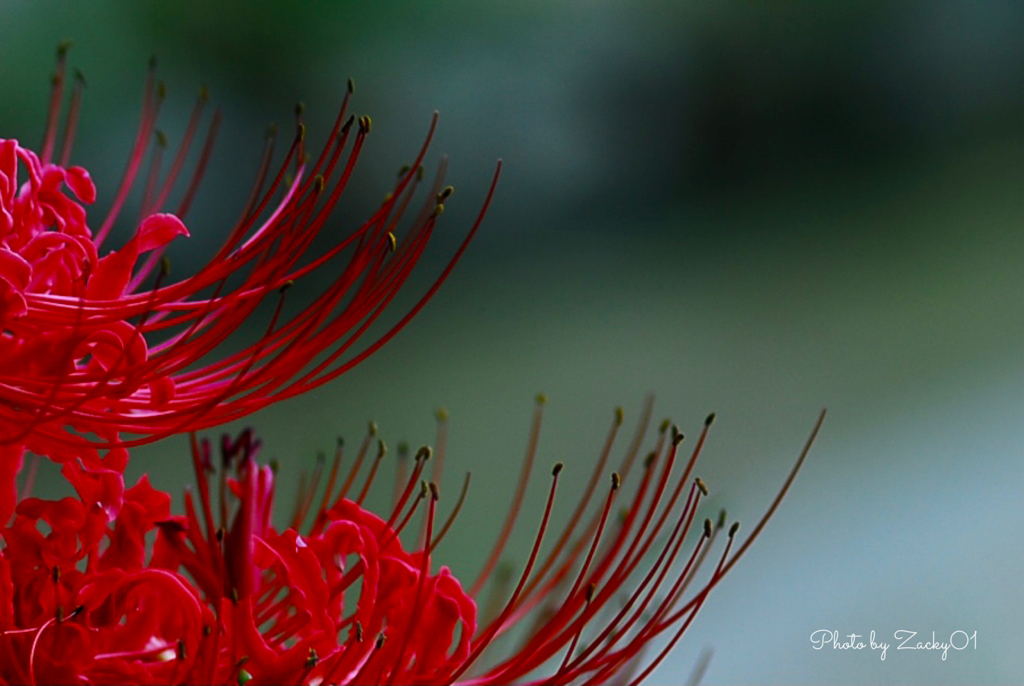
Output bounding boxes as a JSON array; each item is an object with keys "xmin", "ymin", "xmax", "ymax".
[{"xmin": 0, "ymin": 47, "xmax": 500, "ymax": 456}]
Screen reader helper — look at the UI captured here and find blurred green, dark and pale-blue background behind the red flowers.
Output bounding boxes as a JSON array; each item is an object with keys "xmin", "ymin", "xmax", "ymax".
[{"xmin": 0, "ymin": 0, "xmax": 1024, "ymax": 684}]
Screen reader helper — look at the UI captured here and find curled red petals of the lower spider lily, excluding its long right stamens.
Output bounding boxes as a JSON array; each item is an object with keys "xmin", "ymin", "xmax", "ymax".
[{"xmin": 0, "ymin": 434, "xmax": 476, "ymax": 684}]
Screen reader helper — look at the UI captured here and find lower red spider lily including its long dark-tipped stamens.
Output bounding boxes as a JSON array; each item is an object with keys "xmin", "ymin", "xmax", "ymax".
[{"xmin": 0, "ymin": 404, "xmax": 824, "ymax": 684}]
